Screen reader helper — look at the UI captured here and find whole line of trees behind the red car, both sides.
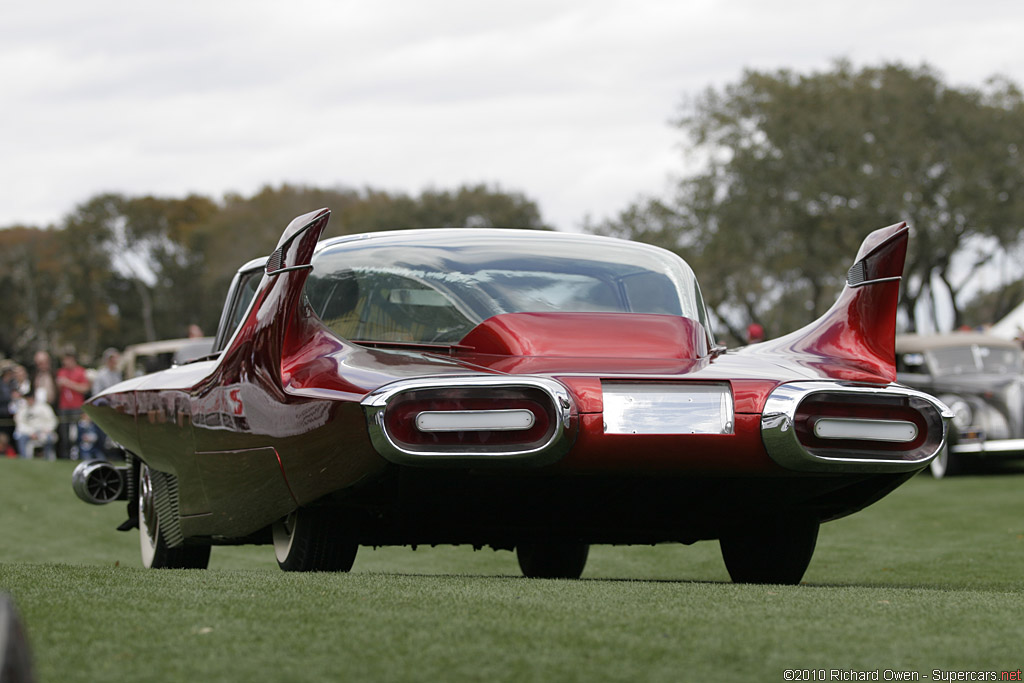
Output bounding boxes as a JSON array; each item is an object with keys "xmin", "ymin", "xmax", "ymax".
[{"xmin": 0, "ymin": 61, "xmax": 1024, "ymax": 357}]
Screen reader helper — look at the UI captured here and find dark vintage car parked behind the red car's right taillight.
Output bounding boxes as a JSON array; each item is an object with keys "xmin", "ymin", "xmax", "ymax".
[{"xmin": 896, "ymin": 332, "xmax": 1024, "ymax": 478}]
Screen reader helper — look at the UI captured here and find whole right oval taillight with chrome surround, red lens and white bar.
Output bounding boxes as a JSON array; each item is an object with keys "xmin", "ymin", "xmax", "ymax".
[{"xmin": 761, "ymin": 382, "xmax": 952, "ymax": 472}]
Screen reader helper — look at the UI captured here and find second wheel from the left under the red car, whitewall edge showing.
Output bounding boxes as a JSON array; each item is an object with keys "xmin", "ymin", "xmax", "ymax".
[{"xmin": 272, "ymin": 508, "xmax": 359, "ymax": 571}]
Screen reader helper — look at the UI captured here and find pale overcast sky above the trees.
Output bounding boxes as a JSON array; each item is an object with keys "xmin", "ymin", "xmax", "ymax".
[{"xmin": 0, "ymin": 0, "xmax": 1024, "ymax": 229}]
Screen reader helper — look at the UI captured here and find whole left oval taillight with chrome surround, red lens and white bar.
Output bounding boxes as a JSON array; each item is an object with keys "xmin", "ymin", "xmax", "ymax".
[{"xmin": 361, "ymin": 375, "xmax": 579, "ymax": 466}]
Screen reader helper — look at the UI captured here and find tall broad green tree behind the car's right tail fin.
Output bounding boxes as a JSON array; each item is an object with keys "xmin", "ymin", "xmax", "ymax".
[{"xmin": 595, "ymin": 61, "xmax": 1024, "ymax": 337}]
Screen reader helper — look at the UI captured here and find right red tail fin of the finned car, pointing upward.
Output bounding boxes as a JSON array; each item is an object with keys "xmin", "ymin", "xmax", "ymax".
[{"xmin": 751, "ymin": 222, "xmax": 909, "ymax": 382}]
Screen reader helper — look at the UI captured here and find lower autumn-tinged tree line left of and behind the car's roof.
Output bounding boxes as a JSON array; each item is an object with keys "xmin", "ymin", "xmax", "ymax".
[{"xmin": 0, "ymin": 184, "xmax": 549, "ymax": 359}]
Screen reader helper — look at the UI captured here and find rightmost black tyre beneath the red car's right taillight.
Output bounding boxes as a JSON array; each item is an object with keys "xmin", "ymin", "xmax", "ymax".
[{"xmin": 719, "ymin": 515, "xmax": 819, "ymax": 585}]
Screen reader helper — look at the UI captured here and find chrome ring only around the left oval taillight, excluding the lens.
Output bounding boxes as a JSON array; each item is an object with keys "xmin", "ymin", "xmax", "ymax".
[{"xmin": 359, "ymin": 375, "xmax": 580, "ymax": 466}]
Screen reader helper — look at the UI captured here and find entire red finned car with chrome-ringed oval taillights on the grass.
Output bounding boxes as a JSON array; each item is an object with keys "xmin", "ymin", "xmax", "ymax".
[{"xmin": 74, "ymin": 210, "xmax": 950, "ymax": 583}]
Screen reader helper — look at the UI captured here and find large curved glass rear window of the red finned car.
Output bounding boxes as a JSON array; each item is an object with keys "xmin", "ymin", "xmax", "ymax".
[{"xmin": 305, "ymin": 229, "xmax": 708, "ymax": 344}]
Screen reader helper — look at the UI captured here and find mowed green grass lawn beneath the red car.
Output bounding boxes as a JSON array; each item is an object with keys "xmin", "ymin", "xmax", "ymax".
[{"xmin": 0, "ymin": 461, "xmax": 1024, "ymax": 682}]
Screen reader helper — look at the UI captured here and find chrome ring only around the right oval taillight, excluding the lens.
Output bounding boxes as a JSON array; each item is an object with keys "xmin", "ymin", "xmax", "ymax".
[{"xmin": 761, "ymin": 381, "xmax": 952, "ymax": 473}]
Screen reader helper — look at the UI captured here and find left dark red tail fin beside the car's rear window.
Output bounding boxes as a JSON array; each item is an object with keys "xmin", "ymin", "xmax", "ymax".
[{"xmin": 220, "ymin": 209, "xmax": 331, "ymax": 388}]
